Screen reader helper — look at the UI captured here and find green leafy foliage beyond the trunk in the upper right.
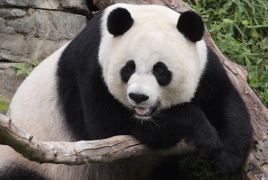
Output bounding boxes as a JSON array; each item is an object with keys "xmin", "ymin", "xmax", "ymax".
[{"xmin": 185, "ymin": 0, "xmax": 268, "ymax": 107}]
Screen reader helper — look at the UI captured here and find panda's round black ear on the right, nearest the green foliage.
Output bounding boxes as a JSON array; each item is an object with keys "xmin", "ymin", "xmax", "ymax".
[{"xmin": 177, "ymin": 11, "xmax": 205, "ymax": 42}]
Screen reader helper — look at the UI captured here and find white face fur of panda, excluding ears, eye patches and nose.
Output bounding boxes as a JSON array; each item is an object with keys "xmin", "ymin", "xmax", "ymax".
[{"xmin": 99, "ymin": 4, "xmax": 207, "ymax": 114}]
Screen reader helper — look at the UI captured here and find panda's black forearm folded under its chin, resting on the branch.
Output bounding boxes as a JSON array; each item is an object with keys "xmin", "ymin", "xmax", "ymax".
[{"xmin": 131, "ymin": 103, "xmax": 222, "ymax": 154}]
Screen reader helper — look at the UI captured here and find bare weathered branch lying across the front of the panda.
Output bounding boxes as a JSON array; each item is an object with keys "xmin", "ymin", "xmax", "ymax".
[{"xmin": 0, "ymin": 114, "xmax": 194, "ymax": 165}]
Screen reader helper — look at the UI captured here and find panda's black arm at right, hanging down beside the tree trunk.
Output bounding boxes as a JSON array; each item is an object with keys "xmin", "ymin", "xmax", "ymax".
[{"xmin": 192, "ymin": 48, "xmax": 252, "ymax": 175}]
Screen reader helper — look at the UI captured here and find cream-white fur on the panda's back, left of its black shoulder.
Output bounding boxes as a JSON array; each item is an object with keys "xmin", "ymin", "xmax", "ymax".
[{"xmin": 10, "ymin": 41, "xmax": 70, "ymax": 141}]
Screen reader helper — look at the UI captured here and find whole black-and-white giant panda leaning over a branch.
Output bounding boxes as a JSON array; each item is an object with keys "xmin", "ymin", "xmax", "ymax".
[{"xmin": 0, "ymin": 4, "xmax": 252, "ymax": 180}]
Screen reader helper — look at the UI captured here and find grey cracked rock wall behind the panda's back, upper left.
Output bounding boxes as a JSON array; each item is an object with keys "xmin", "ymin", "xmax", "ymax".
[{"xmin": 0, "ymin": 0, "xmax": 88, "ymax": 112}]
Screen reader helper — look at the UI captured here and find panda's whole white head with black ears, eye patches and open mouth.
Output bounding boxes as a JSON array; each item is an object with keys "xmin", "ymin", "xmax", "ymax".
[{"xmin": 99, "ymin": 4, "xmax": 207, "ymax": 120}]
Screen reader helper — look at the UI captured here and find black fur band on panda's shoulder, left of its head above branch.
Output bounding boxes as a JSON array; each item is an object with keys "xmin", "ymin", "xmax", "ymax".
[{"xmin": 58, "ymin": 11, "xmax": 132, "ymax": 140}]
